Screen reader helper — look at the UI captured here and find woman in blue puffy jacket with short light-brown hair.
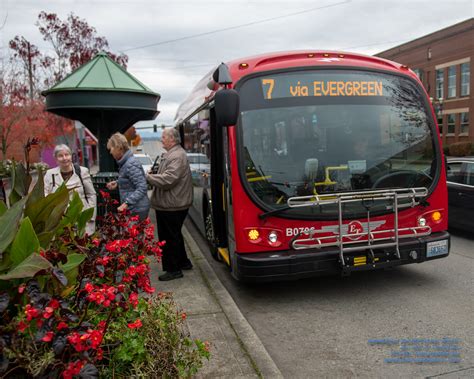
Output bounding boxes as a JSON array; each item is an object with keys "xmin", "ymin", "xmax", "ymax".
[{"xmin": 107, "ymin": 133, "xmax": 150, "ymax": 220}]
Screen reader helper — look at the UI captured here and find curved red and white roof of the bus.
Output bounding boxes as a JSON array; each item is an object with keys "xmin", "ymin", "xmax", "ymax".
[{"xmin": 175, "ymin": 50, "xmax": 416, "ymax": 123}]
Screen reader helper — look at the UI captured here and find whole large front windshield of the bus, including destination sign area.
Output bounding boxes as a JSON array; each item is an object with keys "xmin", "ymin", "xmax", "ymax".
[{"xmin": 239, "ymin": 70, "xmax": 437, "ymax": 217}]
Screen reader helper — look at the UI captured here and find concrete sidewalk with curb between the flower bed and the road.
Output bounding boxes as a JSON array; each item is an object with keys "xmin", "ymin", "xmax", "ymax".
[{"xmin": 150, "ymin": 212, "xmax": 283, "ymax": 378}]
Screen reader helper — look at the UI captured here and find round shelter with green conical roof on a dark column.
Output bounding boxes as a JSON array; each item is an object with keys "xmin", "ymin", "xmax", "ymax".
[{"xmin": 42, "ymin": 52, "xmax": 160, "ymax": 172}]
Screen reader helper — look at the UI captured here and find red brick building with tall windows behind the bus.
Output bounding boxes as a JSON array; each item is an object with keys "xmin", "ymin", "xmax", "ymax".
[{"xmin": 376, "ymin": 18, "xmax": 474, "ymax": 145}]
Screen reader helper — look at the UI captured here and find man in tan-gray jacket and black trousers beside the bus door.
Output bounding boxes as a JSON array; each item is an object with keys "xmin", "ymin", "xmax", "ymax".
[{"xmin": 147, "ymin": 128, "xmax": 193, "ymax": 281}]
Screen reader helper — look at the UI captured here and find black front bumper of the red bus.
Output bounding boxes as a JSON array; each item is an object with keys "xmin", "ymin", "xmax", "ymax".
[{"xmin": 232, "ymin": 232, "xmax": 451, "ymax": 282}]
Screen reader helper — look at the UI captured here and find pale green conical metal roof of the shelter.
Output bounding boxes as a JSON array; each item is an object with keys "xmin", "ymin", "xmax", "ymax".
[{"xmin": 43, "ymin": 52, "xmax": 158, "ymax": 95}]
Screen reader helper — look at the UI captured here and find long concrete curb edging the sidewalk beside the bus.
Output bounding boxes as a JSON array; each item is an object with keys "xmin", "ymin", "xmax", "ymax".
[{"xmin": 183, "ymin": 226, "xmax": 283, "ymax": 378}]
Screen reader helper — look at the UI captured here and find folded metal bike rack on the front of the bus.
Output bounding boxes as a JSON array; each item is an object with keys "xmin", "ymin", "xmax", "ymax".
[{"xmin": 288, "ymin": 187, "xmax": 431, "ymax": 267}]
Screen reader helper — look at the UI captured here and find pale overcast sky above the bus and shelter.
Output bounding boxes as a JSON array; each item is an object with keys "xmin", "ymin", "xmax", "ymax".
[{"xmin": 0, "ymin": 0, "xmax": 474, "ymax": 128}]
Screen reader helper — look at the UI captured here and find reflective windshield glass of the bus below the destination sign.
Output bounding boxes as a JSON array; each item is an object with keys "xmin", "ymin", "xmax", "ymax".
[{"xmin": 241, "ymin": 101, "xmax": 435, "ymax": 214}]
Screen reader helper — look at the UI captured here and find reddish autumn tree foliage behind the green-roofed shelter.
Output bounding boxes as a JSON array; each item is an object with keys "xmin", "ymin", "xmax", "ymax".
[{"xmin": 0, "ymin": 12, "xmax": 128, "ymax": 163}]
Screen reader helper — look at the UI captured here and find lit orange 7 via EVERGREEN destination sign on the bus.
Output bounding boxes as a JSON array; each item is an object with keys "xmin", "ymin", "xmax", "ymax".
[{"xmin": 261, "ymin": 73, "xmax": 387, "ymax": 100}]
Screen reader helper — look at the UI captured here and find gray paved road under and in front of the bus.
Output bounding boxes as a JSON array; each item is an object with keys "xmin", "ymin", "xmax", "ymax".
[{"xmin": 187, "ymin": 222, "xmax": 474, "ymax": 378}]
